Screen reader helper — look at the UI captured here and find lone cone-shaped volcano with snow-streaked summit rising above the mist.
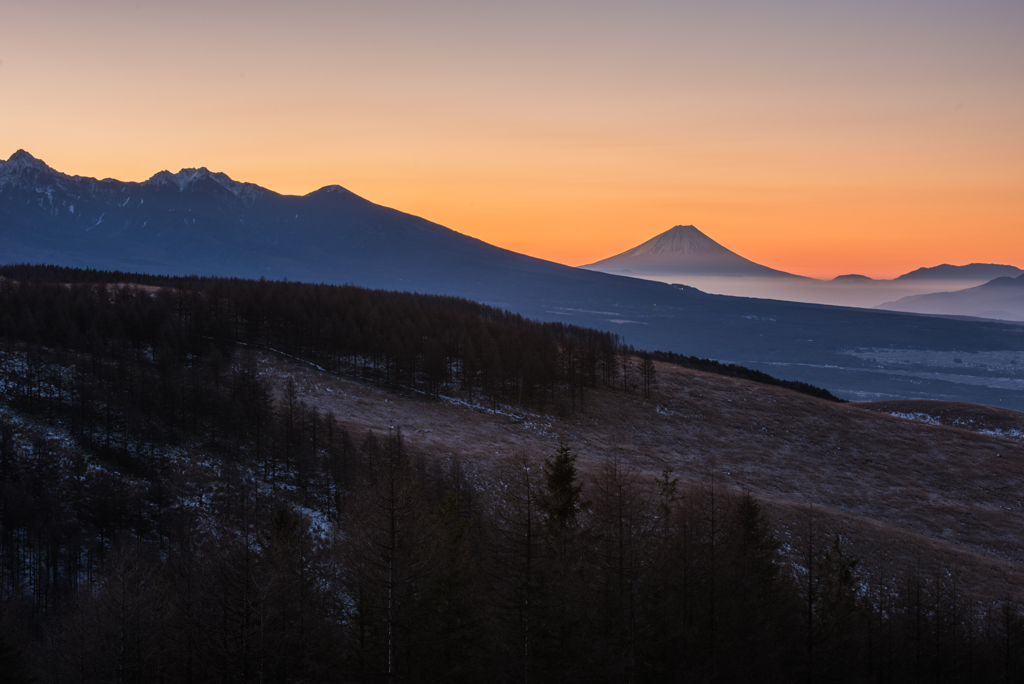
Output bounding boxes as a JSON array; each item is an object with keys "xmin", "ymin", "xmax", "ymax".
[{"xmin": 580, "ymin": 225, "xmax": 802, "ymax": 277}]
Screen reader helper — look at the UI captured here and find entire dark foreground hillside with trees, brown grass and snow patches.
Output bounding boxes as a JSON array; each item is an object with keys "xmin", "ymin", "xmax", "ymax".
[{"xmin": 0, "ymin": 273, "xmax": 1024, "ymax": 682}]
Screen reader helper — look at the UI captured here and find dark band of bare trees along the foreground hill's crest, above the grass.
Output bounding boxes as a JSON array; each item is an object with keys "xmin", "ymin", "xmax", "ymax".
[{"xmin": 0, "ymin": 264, "xmax": 840, "ymax": 403}]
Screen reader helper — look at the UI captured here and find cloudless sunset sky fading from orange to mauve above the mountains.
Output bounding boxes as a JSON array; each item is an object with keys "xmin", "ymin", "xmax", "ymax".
[{"xmin": 0, "ymin": 0, "xmax": 1024, "ymax": 276}]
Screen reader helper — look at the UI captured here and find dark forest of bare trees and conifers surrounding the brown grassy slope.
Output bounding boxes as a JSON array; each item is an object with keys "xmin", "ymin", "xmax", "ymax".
[{"xmin": 0, "ymin": 266, "xmax": 1024, "ymax": 683}]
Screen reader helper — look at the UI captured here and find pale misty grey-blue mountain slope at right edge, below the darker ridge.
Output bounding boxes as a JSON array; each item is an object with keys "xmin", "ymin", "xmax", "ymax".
[{"xmin": 878, "ymin": 272, "xmax": 1024, "ymax": 320}]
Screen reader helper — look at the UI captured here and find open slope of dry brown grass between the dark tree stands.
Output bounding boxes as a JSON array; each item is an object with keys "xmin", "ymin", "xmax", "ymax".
[{"xmin": 263, "ymin": 357, "xmax": 1024, "ymax": 598}]
